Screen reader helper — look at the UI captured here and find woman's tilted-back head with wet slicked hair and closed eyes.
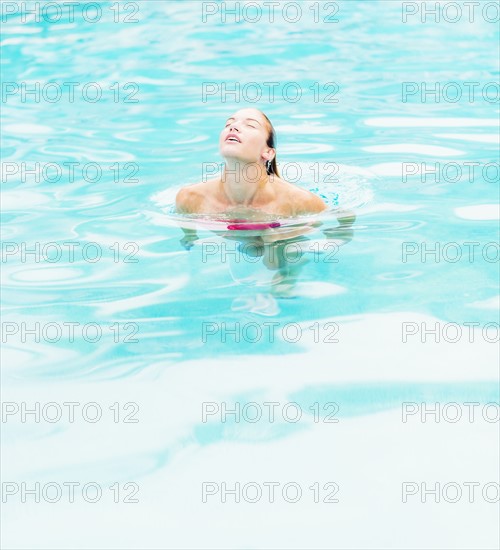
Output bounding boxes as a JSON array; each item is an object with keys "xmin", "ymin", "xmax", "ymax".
[{"xmin": 219, "ymin": 108, "xmax": 279, "ymax": 181}]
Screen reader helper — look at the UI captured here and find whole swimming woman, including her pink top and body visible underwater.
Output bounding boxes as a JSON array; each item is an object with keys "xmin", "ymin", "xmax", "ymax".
[{"xmin": 176, "ymin": 109, "xmax": 348, "ymax": 297}]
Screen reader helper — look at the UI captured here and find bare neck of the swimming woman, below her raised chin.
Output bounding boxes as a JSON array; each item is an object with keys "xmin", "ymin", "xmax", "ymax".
[{"xmin": 221, "ymin": 159, "xmax": 269, "ymax": 206}]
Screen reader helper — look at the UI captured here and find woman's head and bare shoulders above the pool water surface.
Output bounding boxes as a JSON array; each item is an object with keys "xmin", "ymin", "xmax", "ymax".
[{"xmin": 176, "ymin": 108, "xmax": 327, "ymax": 219}]
